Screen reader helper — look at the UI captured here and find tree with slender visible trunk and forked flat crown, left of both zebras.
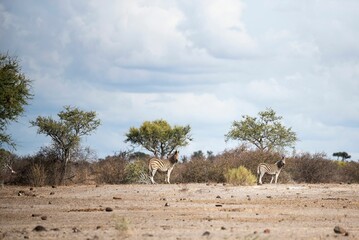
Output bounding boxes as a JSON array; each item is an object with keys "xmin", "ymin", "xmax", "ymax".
[{"xmin": 30, "ymin": 106, "xmax": 100, "ymax": 185}]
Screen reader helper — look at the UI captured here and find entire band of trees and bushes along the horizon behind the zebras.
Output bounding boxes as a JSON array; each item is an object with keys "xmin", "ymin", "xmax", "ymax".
[{"xmin": 0, "ymin": 54, "xmax": 359, "ymax": 186}]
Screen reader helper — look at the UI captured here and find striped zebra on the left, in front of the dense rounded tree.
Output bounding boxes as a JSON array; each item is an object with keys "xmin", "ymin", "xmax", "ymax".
[{"xmin": 148, "ymin": 150, "xmax": 179, "ymax": 184}]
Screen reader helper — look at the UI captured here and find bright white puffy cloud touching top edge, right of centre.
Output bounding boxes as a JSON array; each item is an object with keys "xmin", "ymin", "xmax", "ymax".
[{"xmin": 179, "ymin": 0, "xmax": 256, "ymax": 58}]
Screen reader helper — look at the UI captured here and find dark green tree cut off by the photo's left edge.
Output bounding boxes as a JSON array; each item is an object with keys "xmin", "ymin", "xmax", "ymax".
[{"xmin": 0, "ymin": 53, "xmax": 33, "ymax": 148}]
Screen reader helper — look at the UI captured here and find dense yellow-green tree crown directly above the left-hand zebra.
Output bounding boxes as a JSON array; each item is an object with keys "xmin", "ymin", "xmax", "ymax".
[{"xmin": 125, "ymin": 119, "xmax": 192, "ymax": 158}]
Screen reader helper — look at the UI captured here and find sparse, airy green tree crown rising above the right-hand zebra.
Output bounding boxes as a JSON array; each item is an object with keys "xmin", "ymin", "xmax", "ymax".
[{"xmin": 226, "ymin": 108, "xmax": 298, "ymax": 151}]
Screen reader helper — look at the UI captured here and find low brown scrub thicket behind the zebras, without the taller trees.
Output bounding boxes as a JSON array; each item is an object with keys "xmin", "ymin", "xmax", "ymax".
[{"xmin": 2, "ymin": 146, "xmax": 359, "ymax": 186}]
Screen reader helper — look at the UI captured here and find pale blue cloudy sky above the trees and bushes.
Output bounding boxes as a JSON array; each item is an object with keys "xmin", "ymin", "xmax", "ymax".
[{"xmin": 0, "ymin": 0, "xmax": 359, "ymax": 160}]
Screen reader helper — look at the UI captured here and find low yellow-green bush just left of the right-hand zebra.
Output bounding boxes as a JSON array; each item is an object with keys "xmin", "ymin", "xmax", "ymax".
[{"xmin": 224, "ymin": 166, "xmax": 256, "ymax": 185}]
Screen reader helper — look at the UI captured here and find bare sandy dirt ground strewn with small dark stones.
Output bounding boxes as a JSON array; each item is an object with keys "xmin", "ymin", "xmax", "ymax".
[{"xmin": 0, "ymin": 184, "xmax": 359, "ymax": 239}]
